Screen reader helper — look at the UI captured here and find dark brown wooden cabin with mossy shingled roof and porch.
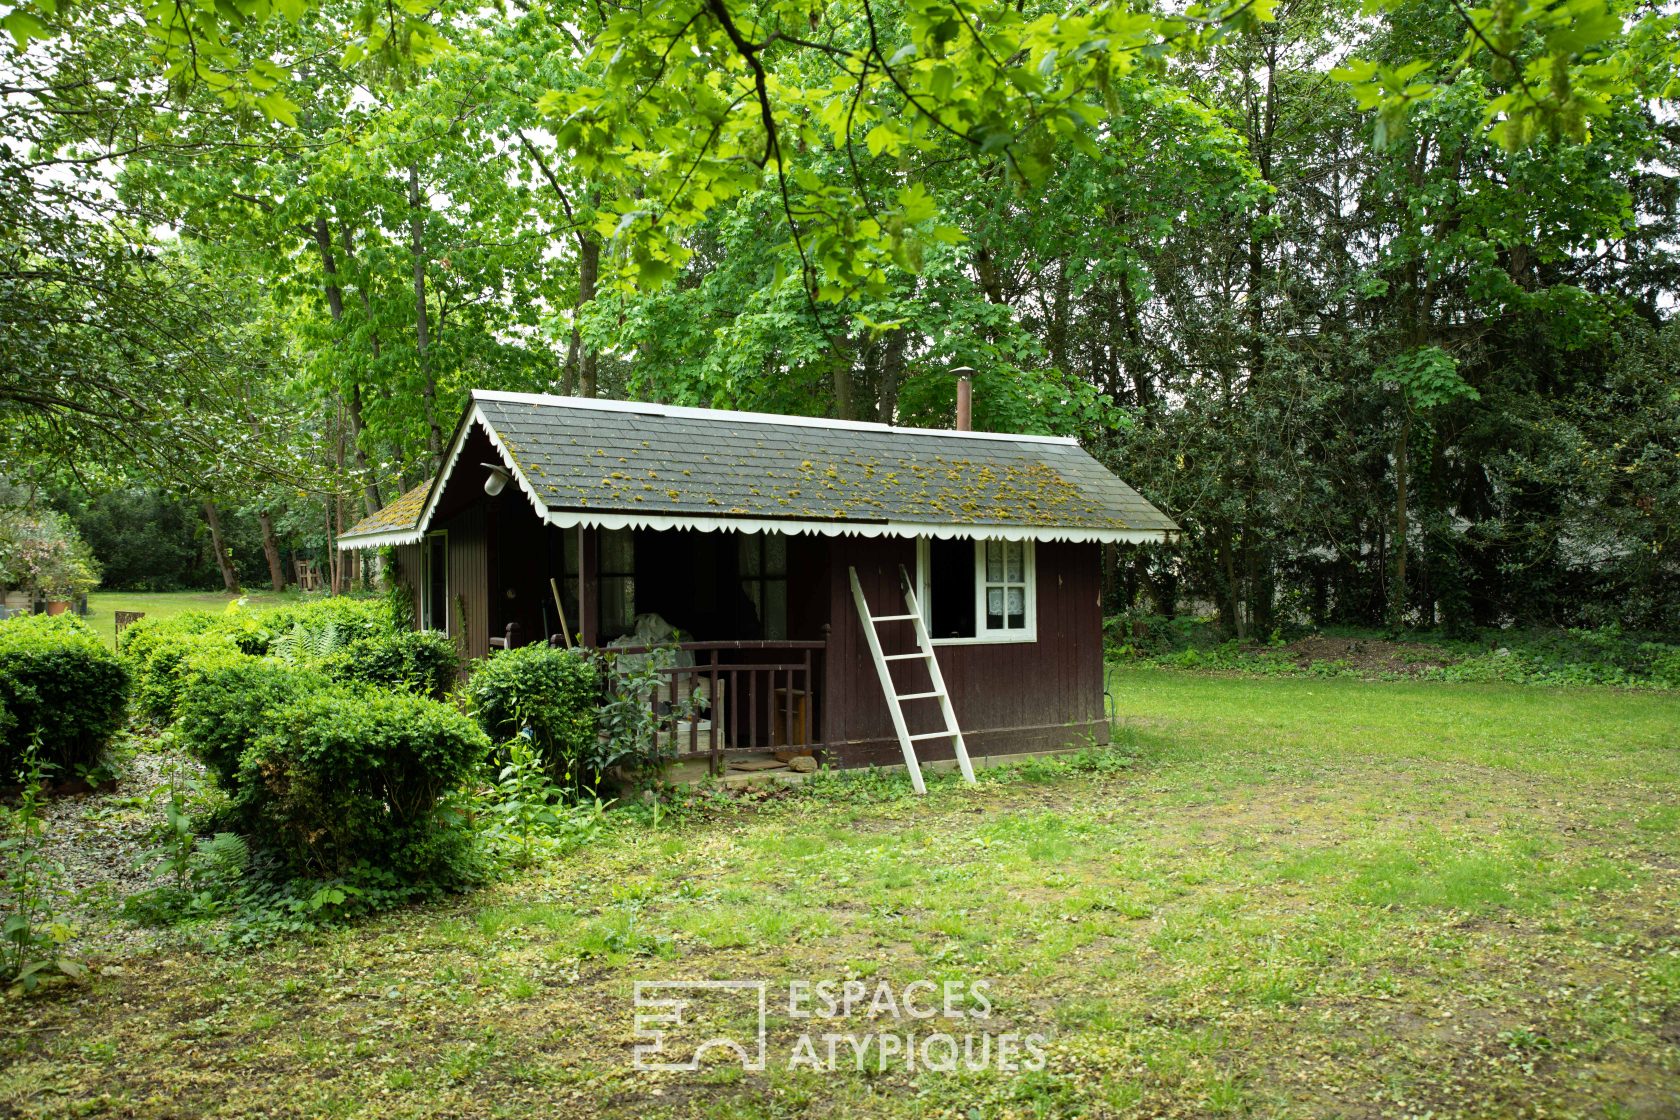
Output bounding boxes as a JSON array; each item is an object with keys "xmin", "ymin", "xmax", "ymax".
[{"xmin": 339, "ymin": 391, "xmax": 1178, "ymax": 779}]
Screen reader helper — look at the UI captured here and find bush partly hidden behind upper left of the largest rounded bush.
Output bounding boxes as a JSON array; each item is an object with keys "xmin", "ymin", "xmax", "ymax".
[{"xmin": 175, "ymin": 650, "xmax": 328, "ymax": 796}]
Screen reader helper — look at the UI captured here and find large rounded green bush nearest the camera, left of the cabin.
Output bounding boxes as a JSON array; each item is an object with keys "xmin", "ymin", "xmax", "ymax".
[{"xmin": 237, "ymin": 685, "xmax": 491, "ymax": 885}]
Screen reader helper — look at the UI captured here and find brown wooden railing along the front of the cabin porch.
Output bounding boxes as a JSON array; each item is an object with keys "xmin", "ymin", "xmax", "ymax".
[{"xmin": 613, "ymin": 641, "xmax": 828, "ymax": 774}]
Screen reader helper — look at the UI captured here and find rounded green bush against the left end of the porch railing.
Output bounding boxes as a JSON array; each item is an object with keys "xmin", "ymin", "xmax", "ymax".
[{"xmin": 467, "ymin": 645, "xmax": 600, "ymax": 776}]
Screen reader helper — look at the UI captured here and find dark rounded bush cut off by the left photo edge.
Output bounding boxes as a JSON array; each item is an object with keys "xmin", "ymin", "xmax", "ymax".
[{"xmin": 0, "ymin": 615, "xmax": 129, "ymax": 782}]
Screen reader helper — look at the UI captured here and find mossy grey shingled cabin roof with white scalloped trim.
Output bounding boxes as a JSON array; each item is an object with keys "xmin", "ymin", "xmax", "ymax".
[{"xmin": 344, "ymin": 391, "xmax": 1178, "ymax": 547}]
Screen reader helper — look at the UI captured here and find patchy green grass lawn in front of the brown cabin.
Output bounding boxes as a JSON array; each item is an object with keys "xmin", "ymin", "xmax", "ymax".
[{"xmin": 0, "ymin": 670, "xmax": 1680, "ymax": 1120}]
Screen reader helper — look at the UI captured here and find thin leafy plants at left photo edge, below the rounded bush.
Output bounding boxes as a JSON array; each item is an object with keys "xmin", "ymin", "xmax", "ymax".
[{"xmin": 0, "ymin": 746, "xmax": 86, "ymax": 992}]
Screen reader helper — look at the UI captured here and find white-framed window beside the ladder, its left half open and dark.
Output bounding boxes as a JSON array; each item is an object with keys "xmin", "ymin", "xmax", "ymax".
[{"xmin": 919, "ymin": 539, "xmax": 1038, "ymax": 643}]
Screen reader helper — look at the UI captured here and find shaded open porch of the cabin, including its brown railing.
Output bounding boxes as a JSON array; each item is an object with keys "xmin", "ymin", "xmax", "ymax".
[{"xmin": 430, "ymin": 463, "xmax": 830, "ymax": 774}]
